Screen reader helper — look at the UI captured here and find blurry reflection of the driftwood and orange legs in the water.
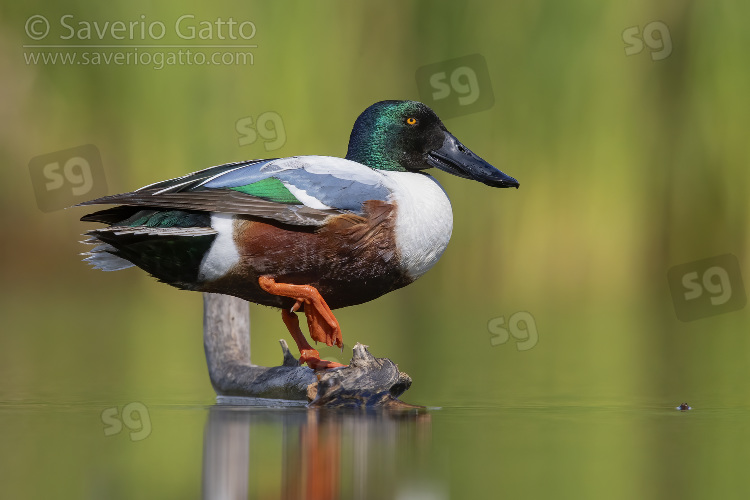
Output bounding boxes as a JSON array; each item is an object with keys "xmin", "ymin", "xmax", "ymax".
[{"xmin": 203, "ymin": 405, "xmax": 447, "ymax": 500}]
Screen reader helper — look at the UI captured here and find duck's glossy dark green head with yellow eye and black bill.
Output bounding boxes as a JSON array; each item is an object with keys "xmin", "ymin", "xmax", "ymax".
[{"xmin": 346, "ymin": 101, "xmax": 519, "ymax": 188}]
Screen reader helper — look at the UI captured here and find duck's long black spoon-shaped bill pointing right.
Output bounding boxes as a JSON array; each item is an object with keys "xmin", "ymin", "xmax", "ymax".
[{"xmin": 427, "ymin": 131, "xmax": 519, "ymax": 188}]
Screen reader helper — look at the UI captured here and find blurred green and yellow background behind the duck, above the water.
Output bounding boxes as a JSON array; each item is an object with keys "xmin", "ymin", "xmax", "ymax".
[{"xmin": 0, "ymin": 0, "xmax": 750, "ymax": 494}]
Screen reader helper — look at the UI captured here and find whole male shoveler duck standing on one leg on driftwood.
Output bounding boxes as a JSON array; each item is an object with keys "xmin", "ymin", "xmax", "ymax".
[{"xmin": 81, "ymin": 101, "xmax": 519, "ymax": 369}]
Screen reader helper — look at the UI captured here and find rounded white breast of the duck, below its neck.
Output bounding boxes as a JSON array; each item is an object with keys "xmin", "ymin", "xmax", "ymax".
[{"xmin": 381, "ymin": 171, "xmax": 453, "ymax": 279}]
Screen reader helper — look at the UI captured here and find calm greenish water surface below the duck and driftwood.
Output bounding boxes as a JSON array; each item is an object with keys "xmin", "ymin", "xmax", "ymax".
[{"xmin": 0, "ymin": 396, "xmax": 750, "ymax": 499}]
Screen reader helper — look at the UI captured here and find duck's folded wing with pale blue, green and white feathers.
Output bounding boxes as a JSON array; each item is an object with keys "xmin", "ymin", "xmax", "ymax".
[{"xmin": 80, "ymin": 156, "xmax": 391, "ymax": 226}]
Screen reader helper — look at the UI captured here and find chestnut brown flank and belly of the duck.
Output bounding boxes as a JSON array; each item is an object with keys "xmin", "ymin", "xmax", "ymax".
[{"xmin": 201, "ymin": 200, "xmax": 411, "ymax": 309}]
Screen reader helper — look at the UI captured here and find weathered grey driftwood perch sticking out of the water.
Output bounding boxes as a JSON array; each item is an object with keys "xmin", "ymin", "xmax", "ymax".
[{"xmin": 203, "ymin": 293, "xmax": 414, "ymax": 408}]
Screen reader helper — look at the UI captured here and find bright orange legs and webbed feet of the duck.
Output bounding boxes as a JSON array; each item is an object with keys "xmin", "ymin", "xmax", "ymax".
[{"xmin": 258, "ymin": 276, "xmax": 344, "ymax": 369}]
